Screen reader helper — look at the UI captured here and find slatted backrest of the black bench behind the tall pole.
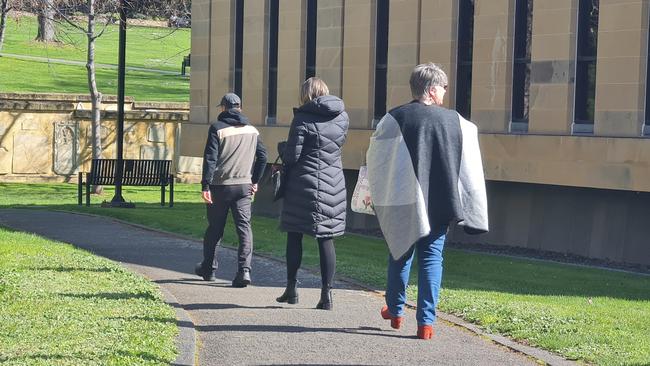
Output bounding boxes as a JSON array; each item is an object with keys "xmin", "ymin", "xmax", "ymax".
[{"xmin": 88, "ymin": 159, "xmax": 172, "ymax": 186}]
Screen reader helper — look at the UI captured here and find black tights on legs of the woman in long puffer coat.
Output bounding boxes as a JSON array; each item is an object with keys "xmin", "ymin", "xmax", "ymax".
[{"xmin": 287, "ymin": 233, "xmax": 336, "ymax": 288}]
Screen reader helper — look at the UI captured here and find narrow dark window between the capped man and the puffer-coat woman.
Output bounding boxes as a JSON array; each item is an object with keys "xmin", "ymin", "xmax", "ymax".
[{"xmin": 266, "ymin": 0, "xmax": 280, "ymax": 124}]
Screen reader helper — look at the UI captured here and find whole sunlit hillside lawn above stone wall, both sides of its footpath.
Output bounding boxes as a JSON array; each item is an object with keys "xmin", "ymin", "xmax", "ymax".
[{"xmin": 0, "ymin": 17, "xmax": 190, "ymax": 102}]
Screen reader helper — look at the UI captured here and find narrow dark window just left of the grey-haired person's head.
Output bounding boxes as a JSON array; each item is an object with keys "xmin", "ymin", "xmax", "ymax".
[{"xmin": 374, "ymin": 0, "xmax": 390, "ymax": 121}]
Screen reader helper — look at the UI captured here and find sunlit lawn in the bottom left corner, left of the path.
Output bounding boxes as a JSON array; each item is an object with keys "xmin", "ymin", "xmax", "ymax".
[{"xmin": 0, "ymin": 227, "xmax": 177, "ymax": 365}]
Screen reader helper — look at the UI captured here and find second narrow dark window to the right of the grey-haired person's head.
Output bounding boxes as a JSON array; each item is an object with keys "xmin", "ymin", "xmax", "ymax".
[{"xmin": 510, "ymin": 0, "xmax": 533, "ymax": 133}]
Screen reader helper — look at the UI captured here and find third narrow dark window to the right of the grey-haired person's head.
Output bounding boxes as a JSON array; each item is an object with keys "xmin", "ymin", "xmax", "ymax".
[{"xmin": 573, "ymin": 0, "xmax": 599, "ymax": 134}]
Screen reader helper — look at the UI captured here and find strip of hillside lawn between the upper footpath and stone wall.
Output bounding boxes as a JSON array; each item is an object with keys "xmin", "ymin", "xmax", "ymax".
[{"xmin": 0, "ymin": 57, "xmax": 190, "ymax": 102}]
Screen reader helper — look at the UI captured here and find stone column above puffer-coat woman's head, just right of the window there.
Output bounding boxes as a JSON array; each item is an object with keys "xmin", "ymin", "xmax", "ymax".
[{"xmin": 316, "ymin": 0, "xmax": 343, "ymax": 96}]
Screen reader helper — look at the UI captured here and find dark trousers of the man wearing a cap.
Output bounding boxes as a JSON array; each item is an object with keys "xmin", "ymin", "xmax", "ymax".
[{"xmin": 202, "ymin": 184, "xmax": 253, "ymax": 271}]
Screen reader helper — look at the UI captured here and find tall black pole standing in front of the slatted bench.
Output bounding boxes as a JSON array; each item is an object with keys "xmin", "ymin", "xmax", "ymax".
[{"xmin": 111, "ymin": 0, "xmax": 131, "ymax": 207}]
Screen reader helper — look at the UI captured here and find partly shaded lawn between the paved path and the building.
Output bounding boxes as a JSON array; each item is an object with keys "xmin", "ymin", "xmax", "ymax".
[{"xmin": 0, "ymin": 183, "xmax": 650, "ymax": 365}]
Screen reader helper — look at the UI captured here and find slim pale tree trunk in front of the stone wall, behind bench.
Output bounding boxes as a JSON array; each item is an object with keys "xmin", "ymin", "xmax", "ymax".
[{"xmin": 86, "ymin": 0, "xmax": 103, "ymax": 194}]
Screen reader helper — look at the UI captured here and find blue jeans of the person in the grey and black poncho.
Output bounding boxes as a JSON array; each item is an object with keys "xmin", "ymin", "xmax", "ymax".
[{"xmin": 386, "ymin": 227, "xmax": 447, "ymax": 325}]
